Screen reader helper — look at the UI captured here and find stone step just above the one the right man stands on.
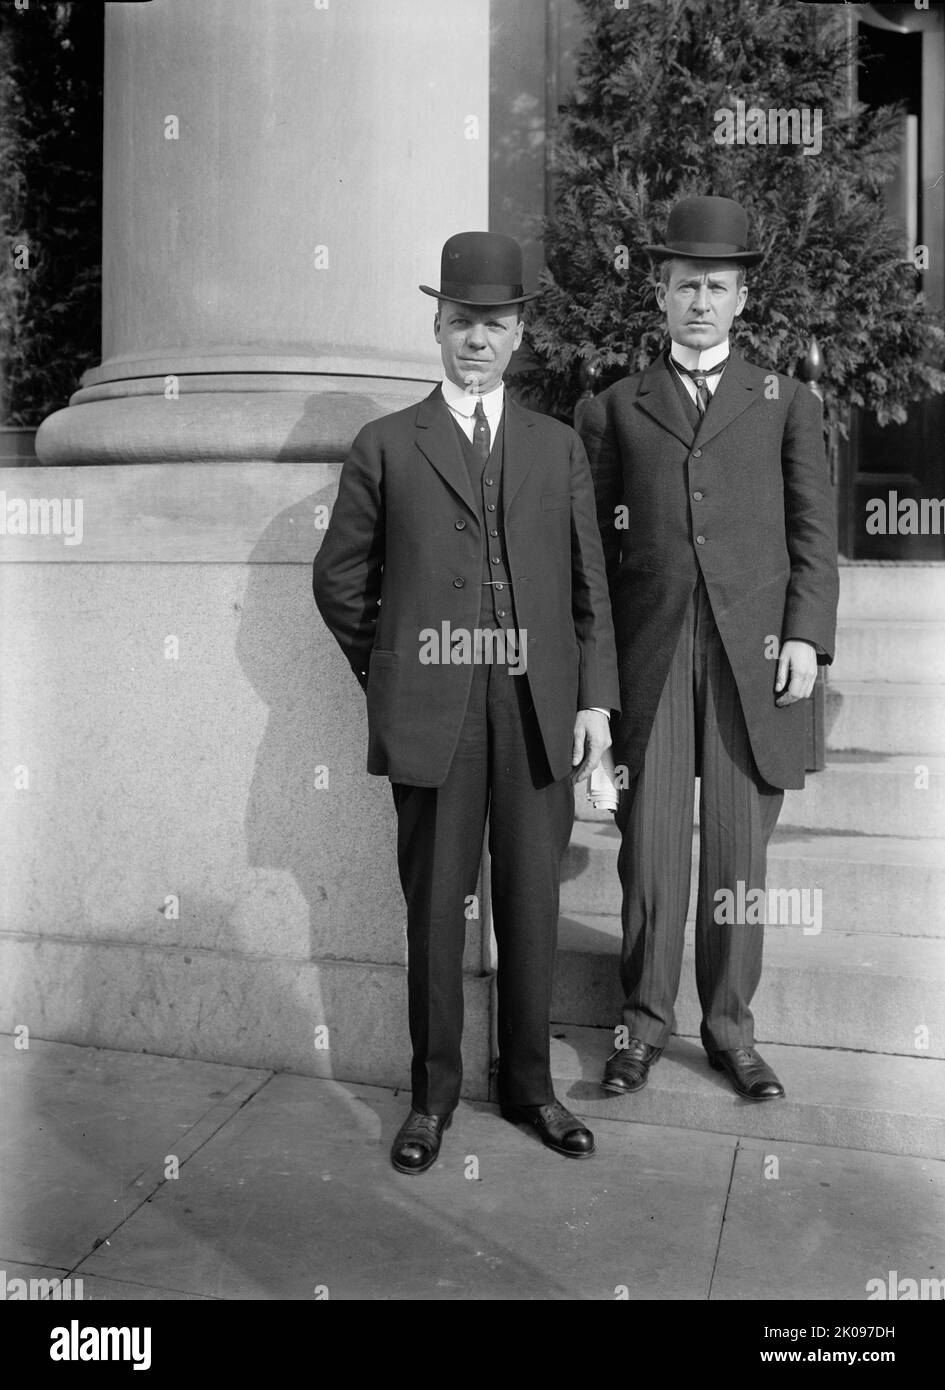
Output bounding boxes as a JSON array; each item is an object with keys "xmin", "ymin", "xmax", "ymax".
[{"xmin": 552, "ymin": 913, "xmax": 945, "ymax": 1058}]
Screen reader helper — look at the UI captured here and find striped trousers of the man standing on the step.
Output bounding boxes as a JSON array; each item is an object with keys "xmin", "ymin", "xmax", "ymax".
[{"xmin": 617, "ymin": 581, "xmax": 784, "ymax": 1051}]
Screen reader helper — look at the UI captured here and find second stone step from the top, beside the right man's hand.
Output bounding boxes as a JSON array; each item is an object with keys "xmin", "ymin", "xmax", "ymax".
[{"xmin": 828, "ymin": 619, "xmax": 945, "ymax": 685}]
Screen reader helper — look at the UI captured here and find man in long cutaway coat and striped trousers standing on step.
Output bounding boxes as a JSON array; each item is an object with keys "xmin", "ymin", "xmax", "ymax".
[{"xmin": 581, "ymin": 197, "xmax": 838, "ymax": 1101}]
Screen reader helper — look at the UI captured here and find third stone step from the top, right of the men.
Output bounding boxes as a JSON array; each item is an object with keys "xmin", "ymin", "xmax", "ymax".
[{"xmin": 825, "ymin": 680, "xmax": 945, "ymax": 760}]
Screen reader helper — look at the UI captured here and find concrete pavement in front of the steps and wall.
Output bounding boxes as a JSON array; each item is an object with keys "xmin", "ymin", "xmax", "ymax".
[{"xmin": 0, "ymin": 1036, "xmax": 945, "ymax": 1301}]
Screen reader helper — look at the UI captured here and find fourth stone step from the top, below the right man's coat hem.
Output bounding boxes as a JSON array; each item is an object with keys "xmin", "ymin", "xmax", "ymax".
[{"xmin": 781, "ymin": 752, "xmax": 945, "ymax": 838}]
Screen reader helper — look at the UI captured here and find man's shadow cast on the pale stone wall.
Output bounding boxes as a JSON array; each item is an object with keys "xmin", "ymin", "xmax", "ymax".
[{"xmin": 236, "ymin": 433, "xmax": 409, "ymax": 1084}]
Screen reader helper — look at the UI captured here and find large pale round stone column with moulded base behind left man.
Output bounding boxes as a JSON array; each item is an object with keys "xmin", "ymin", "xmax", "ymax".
[{"xmin": 38, "ymin": 0, "xmax": 489, "ymax": 464}]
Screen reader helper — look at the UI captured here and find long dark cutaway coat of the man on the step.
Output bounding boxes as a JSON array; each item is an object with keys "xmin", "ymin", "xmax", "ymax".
[{"xmin": 581, "ymin": 352, "xmax": 838, "ymax": 787}]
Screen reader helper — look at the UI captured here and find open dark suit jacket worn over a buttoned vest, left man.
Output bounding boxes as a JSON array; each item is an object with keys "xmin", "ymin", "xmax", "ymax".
[{"xmin": 314, "ymin": 386, "xmax": 620, "ymax": 787}]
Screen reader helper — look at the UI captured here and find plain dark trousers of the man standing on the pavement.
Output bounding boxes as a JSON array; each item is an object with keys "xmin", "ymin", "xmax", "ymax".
[{"xmin": 393, "ymin": 666, "xmax": 574, "ymax": 1115}]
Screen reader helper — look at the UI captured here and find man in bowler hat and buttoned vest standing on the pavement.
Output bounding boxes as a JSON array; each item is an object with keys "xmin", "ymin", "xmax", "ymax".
[{"xmin": 314, "ymin": 232, "xmax": 618, "ymax": 1173}]
